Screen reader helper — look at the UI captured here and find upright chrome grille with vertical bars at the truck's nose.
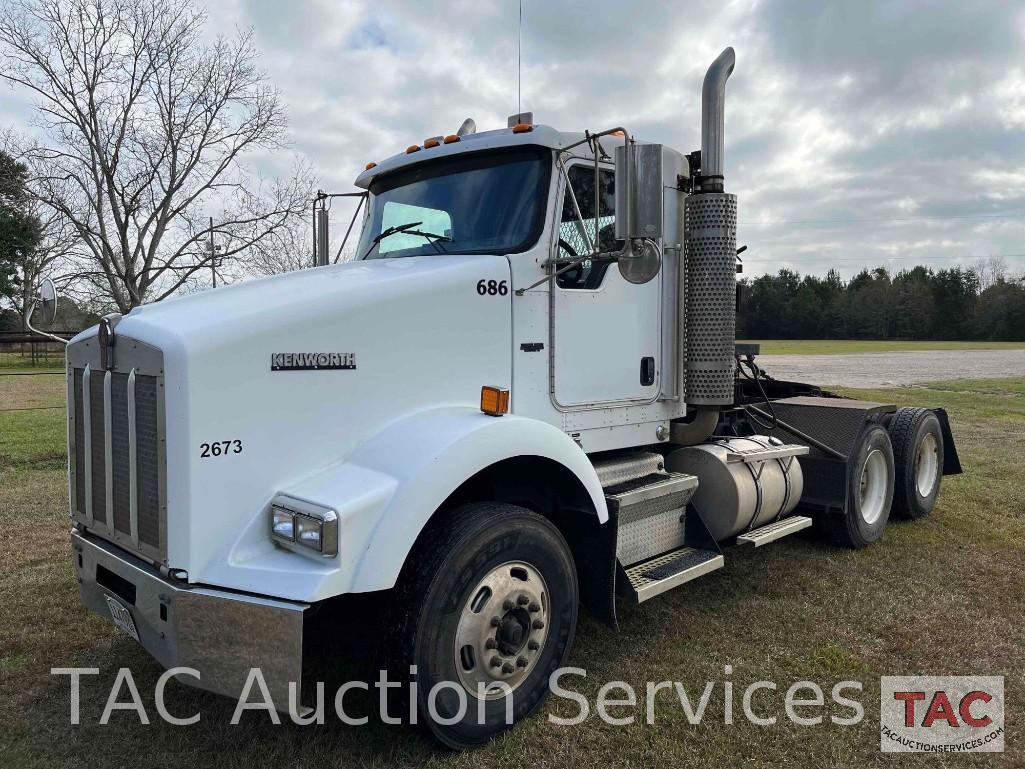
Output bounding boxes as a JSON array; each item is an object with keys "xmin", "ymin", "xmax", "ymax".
[{"xmin": 68, "ymin": 337, "xmax": 167, "ymax": 563}]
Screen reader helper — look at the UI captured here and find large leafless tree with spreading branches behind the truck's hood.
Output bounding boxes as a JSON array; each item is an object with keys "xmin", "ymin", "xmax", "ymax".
[{"xmin": 0, "ymin": 0, "xmax": 310, "ymax": 312}]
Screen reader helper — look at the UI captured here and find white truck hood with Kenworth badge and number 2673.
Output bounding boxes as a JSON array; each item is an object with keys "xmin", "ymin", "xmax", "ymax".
[{"xmin": 69, "ymin": 255, "xmax": 511, "ymax": 597}]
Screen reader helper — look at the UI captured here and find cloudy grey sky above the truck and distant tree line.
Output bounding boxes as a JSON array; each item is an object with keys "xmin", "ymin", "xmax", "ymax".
[{"xmin": 0, "ymin": 0, "xmax": 1025, "ymax": 277}]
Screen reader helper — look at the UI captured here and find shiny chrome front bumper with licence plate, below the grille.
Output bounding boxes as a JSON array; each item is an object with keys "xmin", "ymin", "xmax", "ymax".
[{"xmin": 72, "ymin": 530, "xmax": 310, "ymax": 711}]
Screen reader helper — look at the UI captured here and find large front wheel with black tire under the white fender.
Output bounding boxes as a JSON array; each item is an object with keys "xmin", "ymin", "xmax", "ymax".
[{"xmin": 392, "ymin": 502, "xmax": 578, "ymax": 750}]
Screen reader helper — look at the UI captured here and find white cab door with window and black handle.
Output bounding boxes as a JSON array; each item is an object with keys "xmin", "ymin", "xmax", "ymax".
[{"xmin": 551, "ymin": 162, "xmax": 662, "ymax": 410}]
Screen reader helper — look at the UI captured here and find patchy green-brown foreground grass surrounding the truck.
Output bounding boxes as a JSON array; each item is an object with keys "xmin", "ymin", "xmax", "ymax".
[{"xmin": 0, "ymin": 376, "xmax": 1025, "ymax": 769}]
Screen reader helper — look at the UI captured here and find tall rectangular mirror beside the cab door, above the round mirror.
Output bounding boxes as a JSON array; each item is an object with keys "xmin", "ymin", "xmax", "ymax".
[{"xmin": 616, "ymin": 140, "xmax": 662, "ymax": 241}]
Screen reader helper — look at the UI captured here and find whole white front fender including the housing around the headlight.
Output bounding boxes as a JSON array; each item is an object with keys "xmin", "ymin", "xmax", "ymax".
[{"xmin": 214, "ymin": 406, "xmax": 609, "ymax": 602}]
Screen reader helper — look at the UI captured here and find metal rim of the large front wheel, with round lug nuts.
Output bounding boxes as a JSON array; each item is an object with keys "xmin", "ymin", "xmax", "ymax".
[{"xmin": 454, "ymin": 561, "xmax": 550, "ymax": 699}]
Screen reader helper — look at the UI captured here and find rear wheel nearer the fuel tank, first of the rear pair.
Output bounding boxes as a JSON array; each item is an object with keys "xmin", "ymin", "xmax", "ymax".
[{"xmin": 828, "ymin": 422, "xmax": 894, "ymax": 550}]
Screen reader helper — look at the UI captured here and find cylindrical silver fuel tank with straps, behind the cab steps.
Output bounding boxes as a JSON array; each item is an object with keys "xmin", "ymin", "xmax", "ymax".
[{"xmin": 665, "ymin": 436, "xmax": 808, "ymax": 541}]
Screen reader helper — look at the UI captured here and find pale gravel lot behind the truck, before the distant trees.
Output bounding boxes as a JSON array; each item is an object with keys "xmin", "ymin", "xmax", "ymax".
[{"xmin": 757, "ymin": 350, "xmax": 1025, "ymax": 388}]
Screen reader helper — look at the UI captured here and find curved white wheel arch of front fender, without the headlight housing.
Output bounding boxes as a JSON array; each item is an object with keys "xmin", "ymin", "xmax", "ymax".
[{"xmin": 340, "ymin": 408, "xmax": 609, "ymax": 593}]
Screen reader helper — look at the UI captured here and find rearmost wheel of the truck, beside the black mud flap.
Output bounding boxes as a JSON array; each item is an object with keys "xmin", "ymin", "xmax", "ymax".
[{"xmin": 889, "ymin": 408, "xmax": 943, "ymax": 520}]
